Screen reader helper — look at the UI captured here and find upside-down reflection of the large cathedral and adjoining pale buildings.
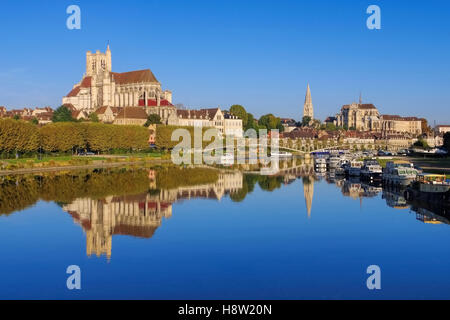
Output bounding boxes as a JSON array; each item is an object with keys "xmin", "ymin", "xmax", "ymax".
[{"xmin": 63, "ymin": 171, "xmax": 243, "ymax": 259}]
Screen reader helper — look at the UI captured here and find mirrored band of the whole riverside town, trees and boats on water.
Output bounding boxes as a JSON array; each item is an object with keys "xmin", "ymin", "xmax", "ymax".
[{"xmin": 0, "ymin": 159, "xmax": 449, "ymax": 259}]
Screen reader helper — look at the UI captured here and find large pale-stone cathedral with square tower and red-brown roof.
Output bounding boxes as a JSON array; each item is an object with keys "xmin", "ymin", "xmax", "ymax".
[{"xmin": 62, "ymin": 45, "xmax": 175, "ymax": 118}]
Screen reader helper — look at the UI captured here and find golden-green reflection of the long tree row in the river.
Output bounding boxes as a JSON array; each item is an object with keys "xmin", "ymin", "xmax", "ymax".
[{"xmin": 0, "ymin": 167, "xmax": 218, "ymax": 214}]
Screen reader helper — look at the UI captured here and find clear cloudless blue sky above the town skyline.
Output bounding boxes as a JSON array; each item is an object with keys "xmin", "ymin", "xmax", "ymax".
[{"xmin": 0, "ymin": 0, "xmax": 450, "ymax": 124}]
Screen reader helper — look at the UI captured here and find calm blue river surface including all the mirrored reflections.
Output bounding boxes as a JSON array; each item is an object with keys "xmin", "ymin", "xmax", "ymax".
[{"xmin": 0, "ymin": 168, "xmax": 450, "ymax": 299}]
